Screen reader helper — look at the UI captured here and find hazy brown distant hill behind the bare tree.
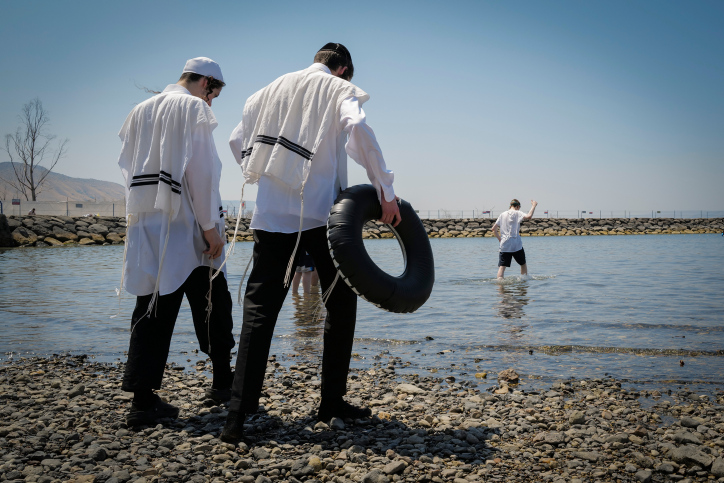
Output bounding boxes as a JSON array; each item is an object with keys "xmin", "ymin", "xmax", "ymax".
[{"xmin": 0, "ymin": 162, "xmax": 126, "ymax": 201}]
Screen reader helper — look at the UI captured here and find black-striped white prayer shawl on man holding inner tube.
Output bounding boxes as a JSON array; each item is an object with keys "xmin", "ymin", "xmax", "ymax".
[{"xmin": 240, "ymin": 65, "xmax": 369, "ymax": 190}]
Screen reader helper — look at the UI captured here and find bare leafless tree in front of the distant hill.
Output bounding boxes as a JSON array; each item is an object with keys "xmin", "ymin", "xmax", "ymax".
[{"xmin": 0, "ymin": 97, "xmax": 68, "ymax": 201}]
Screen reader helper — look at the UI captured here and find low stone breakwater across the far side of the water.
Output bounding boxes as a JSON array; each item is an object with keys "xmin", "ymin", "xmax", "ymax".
[{"xmin": 0, "ymin": 215, "xmax": 724, "ymax": 247}]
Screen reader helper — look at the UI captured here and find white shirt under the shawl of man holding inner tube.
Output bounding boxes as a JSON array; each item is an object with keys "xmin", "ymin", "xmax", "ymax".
[{"xmin": 229, "ymin": 64, "xmax": 395, "ymax": 233}]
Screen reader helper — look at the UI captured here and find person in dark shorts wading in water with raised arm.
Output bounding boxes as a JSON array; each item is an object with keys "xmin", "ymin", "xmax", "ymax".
[{"xmin": 493, "ymin": 199, "xmax": 538, "ymax": 280}]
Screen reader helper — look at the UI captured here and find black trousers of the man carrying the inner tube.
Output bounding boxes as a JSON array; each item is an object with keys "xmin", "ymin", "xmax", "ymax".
[{"xmin": 229, "ymin": 226, "xmax": 357, "ymax": 414}]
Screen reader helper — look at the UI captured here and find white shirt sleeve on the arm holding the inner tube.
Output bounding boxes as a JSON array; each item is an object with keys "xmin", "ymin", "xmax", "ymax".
[{"xmin": 339, "ymin": 96, "xmax": 395, "ymax": 201}]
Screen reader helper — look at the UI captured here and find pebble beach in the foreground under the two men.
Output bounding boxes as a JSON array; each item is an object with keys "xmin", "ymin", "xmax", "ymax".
[{"xmin": 0, "ymin": 355, "xmax": 724, "ymax": 483}]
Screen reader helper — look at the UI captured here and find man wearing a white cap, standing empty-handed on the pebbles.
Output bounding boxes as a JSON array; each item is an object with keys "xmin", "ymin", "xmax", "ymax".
[{"xmin": 118, "ymin": 57, "xmax": 234, "ymax": 426}]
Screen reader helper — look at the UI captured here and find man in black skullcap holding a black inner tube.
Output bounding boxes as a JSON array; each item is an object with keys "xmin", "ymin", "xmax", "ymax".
[{"xmin": 221, "ymin": 43, "xmax": 400, "ymax": 441}]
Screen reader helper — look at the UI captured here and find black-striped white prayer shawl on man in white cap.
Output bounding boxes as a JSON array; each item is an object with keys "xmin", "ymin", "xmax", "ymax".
[{"xmin": 118, "ymin": 84, "xmax": 218, "ymax": 220}]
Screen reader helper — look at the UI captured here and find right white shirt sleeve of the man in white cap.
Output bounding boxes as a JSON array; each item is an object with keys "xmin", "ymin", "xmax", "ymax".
[{"xmin": 184, "ymin": 126, "xmax": 218, "ymax": 231}]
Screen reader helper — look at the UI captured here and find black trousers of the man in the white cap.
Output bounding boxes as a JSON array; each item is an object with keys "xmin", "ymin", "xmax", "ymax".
[{"xmin": 122, "ymin": 267, "xmax": 234, "ymax": 392}]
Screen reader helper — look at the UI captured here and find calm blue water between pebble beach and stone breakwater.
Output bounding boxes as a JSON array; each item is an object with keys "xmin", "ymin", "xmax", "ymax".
[{"xmin": 0, "ymin": 235, "xmax": 724, "ymax": 389}]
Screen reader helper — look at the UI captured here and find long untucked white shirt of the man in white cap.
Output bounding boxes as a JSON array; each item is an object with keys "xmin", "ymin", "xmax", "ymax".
[{"xmin": 124, "ymin": 84, "xmax": 226, "ymax": 296}]
